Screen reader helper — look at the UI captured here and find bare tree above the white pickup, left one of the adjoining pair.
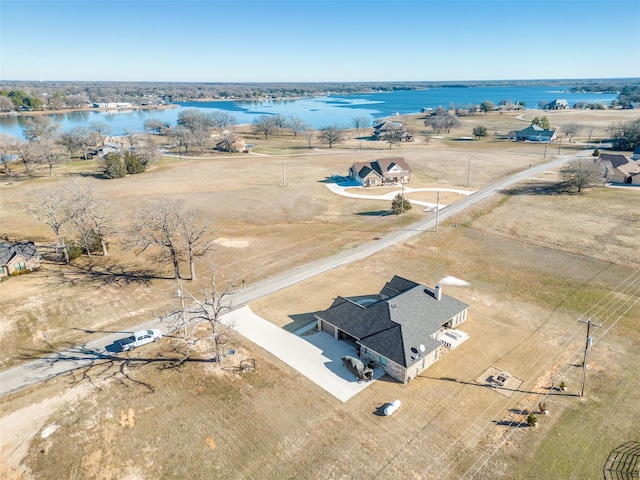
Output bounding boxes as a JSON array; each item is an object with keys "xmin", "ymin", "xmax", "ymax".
[{"xmin": 130, "ymin": 200, "xmax": 184, "ymax": 279}]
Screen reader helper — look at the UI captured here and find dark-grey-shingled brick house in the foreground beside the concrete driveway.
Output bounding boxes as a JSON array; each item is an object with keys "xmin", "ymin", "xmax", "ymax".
[{"xmin": 315, "ymin": 275, "xmax": 469, "ymax": 384}]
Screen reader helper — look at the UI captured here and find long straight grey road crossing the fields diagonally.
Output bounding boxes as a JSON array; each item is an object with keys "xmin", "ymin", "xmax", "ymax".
[{"xmin": 0, "ymin": 152, "xmax": 576, "ymax": 396}]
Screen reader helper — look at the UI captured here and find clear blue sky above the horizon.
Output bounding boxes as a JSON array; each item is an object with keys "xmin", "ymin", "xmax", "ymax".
[{"xmin": 0, "ymin": 0, "xmax": 640, "ymax": 82}]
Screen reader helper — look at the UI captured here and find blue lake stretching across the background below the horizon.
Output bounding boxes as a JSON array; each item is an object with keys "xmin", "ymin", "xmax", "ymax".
[{"xmin": 0, "ymin": 85, "xmax": 617, "ymax": 138}]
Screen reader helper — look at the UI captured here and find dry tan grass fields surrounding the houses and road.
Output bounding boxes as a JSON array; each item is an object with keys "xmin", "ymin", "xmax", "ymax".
[{"xmin": 0, "ymin": 112, "xmax": 640, "ymax": 480}]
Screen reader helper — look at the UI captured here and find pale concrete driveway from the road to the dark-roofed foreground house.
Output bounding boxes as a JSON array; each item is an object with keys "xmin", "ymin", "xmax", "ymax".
[{"xmin": 222, "ymin": 306, "xmax": 384, "ymax": 402}]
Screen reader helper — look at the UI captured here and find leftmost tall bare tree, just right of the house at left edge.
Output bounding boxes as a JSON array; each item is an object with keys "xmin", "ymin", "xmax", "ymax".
[{"xmin": 22, "ymin": 185, "xmax": 70, "ymax": 265}]
